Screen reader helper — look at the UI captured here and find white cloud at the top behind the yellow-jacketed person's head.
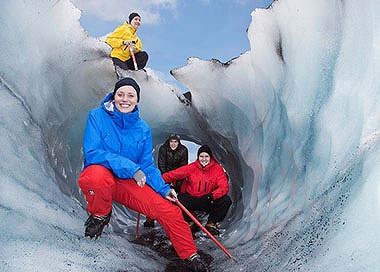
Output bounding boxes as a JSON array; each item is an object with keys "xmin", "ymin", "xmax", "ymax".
[{"xmin": 72, "ymin": 0, "xmax": 178, "ymax": 24}]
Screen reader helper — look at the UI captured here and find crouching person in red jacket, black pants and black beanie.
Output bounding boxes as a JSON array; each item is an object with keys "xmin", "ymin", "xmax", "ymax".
[{"xmin": 162, "ymin": 145, "xmax": 232, "ymax": 235}]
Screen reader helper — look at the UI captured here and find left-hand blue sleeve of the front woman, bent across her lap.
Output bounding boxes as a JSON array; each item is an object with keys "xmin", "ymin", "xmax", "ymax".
[{"xmin": 83, "ymin": 112, "xmax": 139, "ymax": 179}]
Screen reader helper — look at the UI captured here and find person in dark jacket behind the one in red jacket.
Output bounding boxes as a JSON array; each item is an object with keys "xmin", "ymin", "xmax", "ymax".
[{"xmin": 144, "ymin": 133, "xmax": 189, "ymax": 228}]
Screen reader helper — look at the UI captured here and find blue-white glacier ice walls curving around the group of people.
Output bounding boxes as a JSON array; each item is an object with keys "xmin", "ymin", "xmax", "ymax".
[{"xmin": 0, "ymin": 0, "xmax": 380, "ymax": 272}]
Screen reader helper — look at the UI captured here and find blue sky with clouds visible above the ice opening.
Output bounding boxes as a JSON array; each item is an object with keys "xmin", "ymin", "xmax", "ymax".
[{"xmin": 72, "ymin": 0, "xmax": 273, "ymax": 88}]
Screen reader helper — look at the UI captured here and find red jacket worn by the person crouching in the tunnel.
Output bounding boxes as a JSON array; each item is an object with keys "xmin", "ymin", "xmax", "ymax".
[{"xmin": 162, "ymin": 158, "xmax": 229, "ymax": 200}]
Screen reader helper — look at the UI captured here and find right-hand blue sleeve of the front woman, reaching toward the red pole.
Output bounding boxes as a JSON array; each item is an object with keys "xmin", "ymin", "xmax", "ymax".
[{"xmin": 139, "ymin": 126, "xmax": 170, "ymax": 197}]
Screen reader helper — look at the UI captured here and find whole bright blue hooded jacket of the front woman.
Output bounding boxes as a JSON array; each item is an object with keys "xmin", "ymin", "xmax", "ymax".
[{"xmin": 83, "ymin": 93, "xmax": 170, "ymax": 197}]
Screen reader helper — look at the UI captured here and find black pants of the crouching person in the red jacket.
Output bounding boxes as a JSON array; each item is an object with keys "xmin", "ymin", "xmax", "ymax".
[{"xmin": 178, "ymin": 191, "xmax": 232, "ymax": 223}]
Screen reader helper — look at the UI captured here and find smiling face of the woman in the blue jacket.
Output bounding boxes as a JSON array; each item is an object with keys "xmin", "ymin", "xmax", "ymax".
[{"xmin": 114, "ymin": 85, "xmax": 138, "ymax": 113}]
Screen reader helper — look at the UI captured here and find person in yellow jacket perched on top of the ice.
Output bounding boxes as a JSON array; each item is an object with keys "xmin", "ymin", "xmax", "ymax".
[{"xmin": 106, "ymin": 12, "xmax": 148, "ymax": 70}]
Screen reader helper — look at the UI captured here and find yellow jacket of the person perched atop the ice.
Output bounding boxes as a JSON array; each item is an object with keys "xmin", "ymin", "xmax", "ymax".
[{"xmin": 106, "ymin": 22, "xmax": 142, "ymax": 61}]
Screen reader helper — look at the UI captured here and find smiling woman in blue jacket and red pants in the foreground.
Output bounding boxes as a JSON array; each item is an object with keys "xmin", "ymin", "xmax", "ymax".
[{"xmin": 78, "ymin": 77, "xmax": 209, "ymax": 271}]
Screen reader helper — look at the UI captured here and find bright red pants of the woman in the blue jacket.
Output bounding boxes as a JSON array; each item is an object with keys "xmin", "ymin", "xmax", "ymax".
[{"xmin": 78, "ymin": 165, "xmax": 197, "ymax": 259}]
